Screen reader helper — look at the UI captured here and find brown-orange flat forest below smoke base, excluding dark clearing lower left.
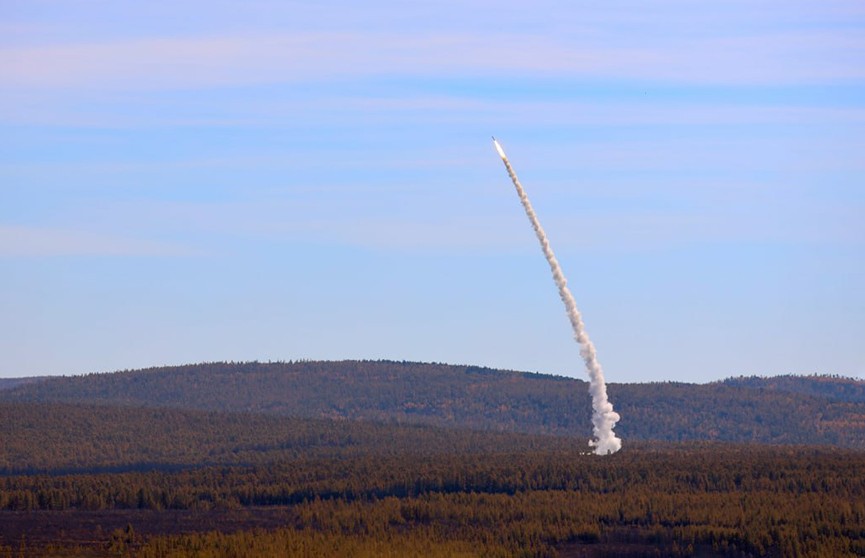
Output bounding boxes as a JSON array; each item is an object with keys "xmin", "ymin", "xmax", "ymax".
[{"xmin": 0, "ymin": 445, "xmax": 865, "ymax": 556}]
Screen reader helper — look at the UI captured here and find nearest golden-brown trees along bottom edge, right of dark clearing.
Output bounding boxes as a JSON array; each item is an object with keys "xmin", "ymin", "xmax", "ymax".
[{"xmin": 138, "ymin": 491, "xmax": 865, "ymax": 558}]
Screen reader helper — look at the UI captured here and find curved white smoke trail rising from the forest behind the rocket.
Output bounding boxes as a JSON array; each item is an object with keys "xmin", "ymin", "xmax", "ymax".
[{"xmin": 493, "ymin": 138, "xmax": 622, "ymax": 455}]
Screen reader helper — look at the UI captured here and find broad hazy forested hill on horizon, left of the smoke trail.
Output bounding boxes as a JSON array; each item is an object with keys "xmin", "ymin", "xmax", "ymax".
[{"xmin": 0, "ymin": 361, "xmax": 588, "ymax": 431}]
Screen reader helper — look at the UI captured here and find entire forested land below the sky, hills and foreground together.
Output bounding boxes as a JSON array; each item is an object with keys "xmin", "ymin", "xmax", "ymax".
[{"xmin": 0, "ymin": 362, "xmax": 865, "ymax": 558}]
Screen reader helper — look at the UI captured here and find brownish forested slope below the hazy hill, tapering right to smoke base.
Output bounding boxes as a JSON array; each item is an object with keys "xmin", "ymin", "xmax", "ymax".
[{"xmin": 0, "ymin": 403, "xmax": 564, "ymax": 475}]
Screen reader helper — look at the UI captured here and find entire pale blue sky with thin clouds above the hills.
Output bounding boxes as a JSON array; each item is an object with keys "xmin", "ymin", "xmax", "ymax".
[{"xmin": 0, "ymin": 0, "xmax": 865, "ymax": 382}]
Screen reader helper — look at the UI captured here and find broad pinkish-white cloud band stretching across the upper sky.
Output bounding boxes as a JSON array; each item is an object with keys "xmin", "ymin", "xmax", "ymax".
[{"xmin": 0, "ymin": 31, "xmax": 865, "ymax": 90}]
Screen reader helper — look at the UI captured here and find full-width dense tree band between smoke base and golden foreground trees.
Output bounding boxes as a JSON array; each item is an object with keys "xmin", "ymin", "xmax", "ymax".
[{"xmin": 6, "ymin": 445, "xmax": 865, "ymax": 510}]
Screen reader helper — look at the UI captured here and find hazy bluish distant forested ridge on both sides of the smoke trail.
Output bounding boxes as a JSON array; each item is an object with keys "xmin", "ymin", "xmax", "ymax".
[{"xmin": 0, "ymin": 361, "xmax": 865, "ymax": 448}]
